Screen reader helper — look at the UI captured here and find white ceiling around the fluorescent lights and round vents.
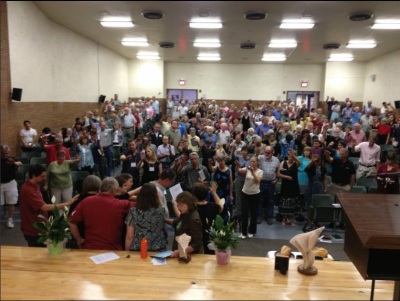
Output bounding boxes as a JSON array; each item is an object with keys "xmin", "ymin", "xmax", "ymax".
[{"xmin": 34, "ymin": 1, "xmax": 400, "ymax": 64}]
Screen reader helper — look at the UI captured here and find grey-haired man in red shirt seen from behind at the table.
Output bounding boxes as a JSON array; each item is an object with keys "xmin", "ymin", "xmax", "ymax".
[{"xmin": 70, "ymin": 177, "xmax": 135, "ymax": 250}]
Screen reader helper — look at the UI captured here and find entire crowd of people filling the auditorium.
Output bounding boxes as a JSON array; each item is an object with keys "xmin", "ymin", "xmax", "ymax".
[{"xmin": 1, "ymin": 94, "xmax": 400, "ymax": 257}]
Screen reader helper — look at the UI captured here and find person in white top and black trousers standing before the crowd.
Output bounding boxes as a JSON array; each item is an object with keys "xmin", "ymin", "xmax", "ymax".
[{"xmin": 257, "ymin": 145, "xmax": 279, "ymax": 225}]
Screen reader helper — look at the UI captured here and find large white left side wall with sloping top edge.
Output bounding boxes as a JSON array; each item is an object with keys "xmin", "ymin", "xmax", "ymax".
[{"xmin": 7, "ymin": 1, "xmax": 128, "ymax": 102}]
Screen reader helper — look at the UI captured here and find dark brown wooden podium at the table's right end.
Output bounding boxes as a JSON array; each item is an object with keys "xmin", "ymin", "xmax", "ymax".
[{"xmin": 336, "ymin": 193, "xmax": 400, "ymax": 300}]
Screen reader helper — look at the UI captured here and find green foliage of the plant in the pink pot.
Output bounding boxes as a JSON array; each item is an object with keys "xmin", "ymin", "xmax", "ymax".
[{"xmin": 207, "ymin": 215, "xmax": 239, "ymax": 251}]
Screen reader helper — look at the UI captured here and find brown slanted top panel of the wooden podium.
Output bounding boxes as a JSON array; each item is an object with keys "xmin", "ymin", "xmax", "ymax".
[{"xmin": 336, "ymin": 193, "xmax": 400, "ymax": 250}]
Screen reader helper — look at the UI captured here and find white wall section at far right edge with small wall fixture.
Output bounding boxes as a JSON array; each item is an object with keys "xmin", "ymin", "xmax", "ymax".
[{"xmin": 364, "ymin": 50, "xmax": 400, "ymax": 107}]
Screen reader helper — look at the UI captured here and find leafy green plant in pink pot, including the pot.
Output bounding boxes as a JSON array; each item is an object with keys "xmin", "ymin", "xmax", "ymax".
[{"xmin": 207, "ymin": 215, "xmax": 239, "ymax": 264}]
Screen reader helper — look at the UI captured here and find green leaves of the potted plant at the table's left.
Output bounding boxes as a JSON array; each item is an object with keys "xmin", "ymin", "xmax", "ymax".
[{"xmin": 32, "ymin": 204, "xmax": 71, "ymax": 245}]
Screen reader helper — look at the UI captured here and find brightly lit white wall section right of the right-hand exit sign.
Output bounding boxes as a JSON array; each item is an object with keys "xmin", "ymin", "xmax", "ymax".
[{"xmin": 321, "ymin": 62, "xmax": 365, "ymax": 101}]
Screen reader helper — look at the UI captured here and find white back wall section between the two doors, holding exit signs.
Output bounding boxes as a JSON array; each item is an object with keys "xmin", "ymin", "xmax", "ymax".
[{"xmin": 165, "ymin": 63, "xmax": 324, "ymax": 100}]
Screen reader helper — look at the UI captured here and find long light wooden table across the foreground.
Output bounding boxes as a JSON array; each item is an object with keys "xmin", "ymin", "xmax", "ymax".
[{"xmin": 1, "ymin": 246, "xmax": 393, "ymax": 300}]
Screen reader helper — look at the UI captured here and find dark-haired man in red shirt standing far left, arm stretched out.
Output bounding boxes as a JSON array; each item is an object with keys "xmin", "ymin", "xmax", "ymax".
[{"xmin": 19, "ymin": 165, "xmax": 79, "ymax": 247}]
